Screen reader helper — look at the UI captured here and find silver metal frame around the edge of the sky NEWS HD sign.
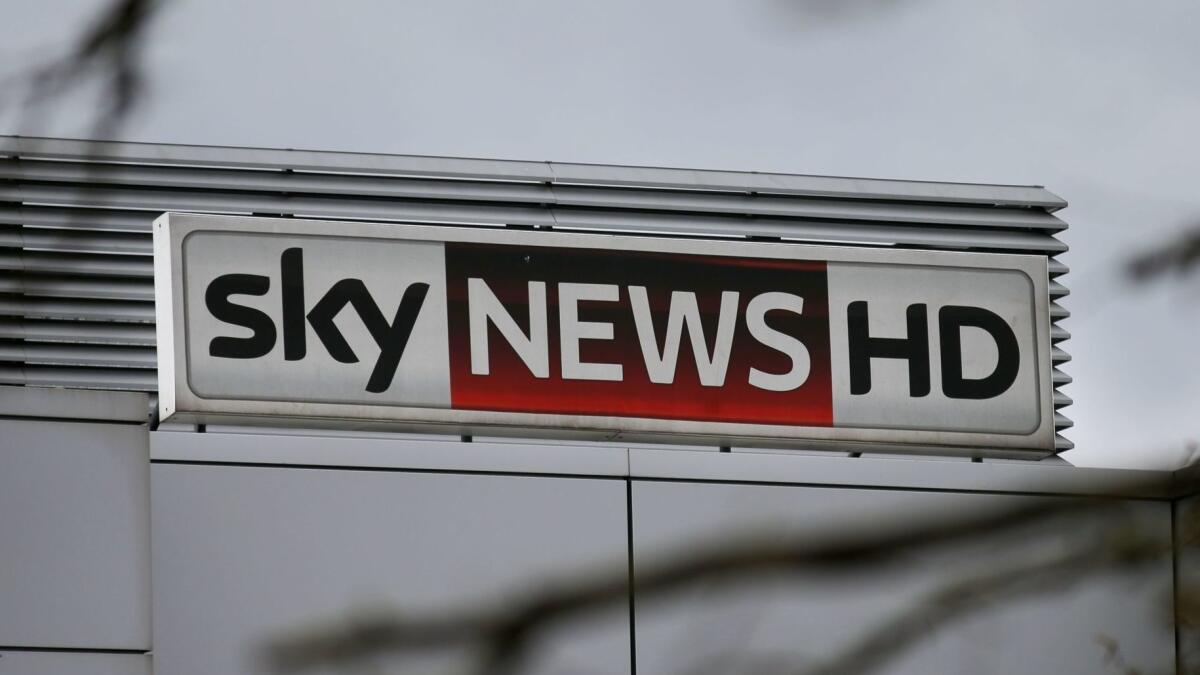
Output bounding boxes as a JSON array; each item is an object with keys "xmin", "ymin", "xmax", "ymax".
[{"xmin": 154, "ymin": 214, "xmax": 1055, "ymax": 458}]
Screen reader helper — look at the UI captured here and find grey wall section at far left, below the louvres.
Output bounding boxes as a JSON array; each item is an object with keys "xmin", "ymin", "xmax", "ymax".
[{"xmin": 0, "ymin": 388, "xmax": 150, "ymax": 675}]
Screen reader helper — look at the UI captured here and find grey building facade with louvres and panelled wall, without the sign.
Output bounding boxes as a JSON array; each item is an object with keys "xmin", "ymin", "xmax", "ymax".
[{"xmin": 0, "ymin": 138, "xmax": 1196, "ymax": 675}]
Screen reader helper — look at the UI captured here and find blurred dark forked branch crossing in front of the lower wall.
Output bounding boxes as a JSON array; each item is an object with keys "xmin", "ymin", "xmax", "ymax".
[{"xmin": 265, "ymin": 480, "xmax": 1190, "ymax": 675}]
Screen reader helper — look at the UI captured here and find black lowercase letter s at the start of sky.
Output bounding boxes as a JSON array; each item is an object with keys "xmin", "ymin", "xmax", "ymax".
[{"xmin": 204, "ymin": 274, "xmax": 275, "ymax": 359}]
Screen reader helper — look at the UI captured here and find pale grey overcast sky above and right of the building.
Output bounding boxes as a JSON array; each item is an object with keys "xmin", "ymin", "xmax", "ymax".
[{"xmin": 0, "ymin": 0, "xmax": 1200, "ymax": 466}]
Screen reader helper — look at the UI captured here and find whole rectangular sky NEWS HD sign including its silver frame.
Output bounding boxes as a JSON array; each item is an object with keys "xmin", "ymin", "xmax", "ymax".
[{"xmin": 155, "ymin": 214, "xmax": 1055, "ymax": 456}]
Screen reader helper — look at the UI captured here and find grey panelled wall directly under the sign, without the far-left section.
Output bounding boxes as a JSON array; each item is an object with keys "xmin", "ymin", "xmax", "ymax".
[{"xmin": 152, "ymin": 428, "xmax": 1174, "ymax": 675}]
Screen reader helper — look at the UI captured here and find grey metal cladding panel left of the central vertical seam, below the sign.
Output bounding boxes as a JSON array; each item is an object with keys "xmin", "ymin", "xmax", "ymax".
[{"xmin": 151, "ymin": 456, "xmax": 631, "ymax": 675}]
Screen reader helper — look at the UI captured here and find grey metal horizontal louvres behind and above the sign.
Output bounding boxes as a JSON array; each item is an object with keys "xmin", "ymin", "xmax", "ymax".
[{"xmin": 0, "ymin": 137, "xmax": 1072, "ymax": 450}]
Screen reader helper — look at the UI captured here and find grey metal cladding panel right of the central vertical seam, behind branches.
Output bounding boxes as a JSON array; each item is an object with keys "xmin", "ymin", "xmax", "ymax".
[{"xmin": 631, "ymin": 478, "xmax": 1175, "ymax": 675}]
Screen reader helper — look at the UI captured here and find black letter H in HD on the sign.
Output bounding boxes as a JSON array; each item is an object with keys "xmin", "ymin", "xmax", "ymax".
[{"xmin": 846, "ymin": 300, "xmax": 929, "ymax": 398}]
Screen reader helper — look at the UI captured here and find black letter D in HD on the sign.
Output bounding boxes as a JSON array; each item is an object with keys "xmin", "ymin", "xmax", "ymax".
[{"xmin": 937, "ymin": 305, "xmax": 1021, "ymax": 399}]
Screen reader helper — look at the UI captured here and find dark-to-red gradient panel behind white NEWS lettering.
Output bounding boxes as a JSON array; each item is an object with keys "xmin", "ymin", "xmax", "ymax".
[{"xmin": 445, "ymin": 244, "xmax": 833, "ymax": 426}]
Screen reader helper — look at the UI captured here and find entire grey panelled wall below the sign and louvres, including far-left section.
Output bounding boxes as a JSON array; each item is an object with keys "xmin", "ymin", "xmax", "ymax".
[{"xmin": 0, "ymin": 387, "xmax": 1185, "ymax": 675}]
